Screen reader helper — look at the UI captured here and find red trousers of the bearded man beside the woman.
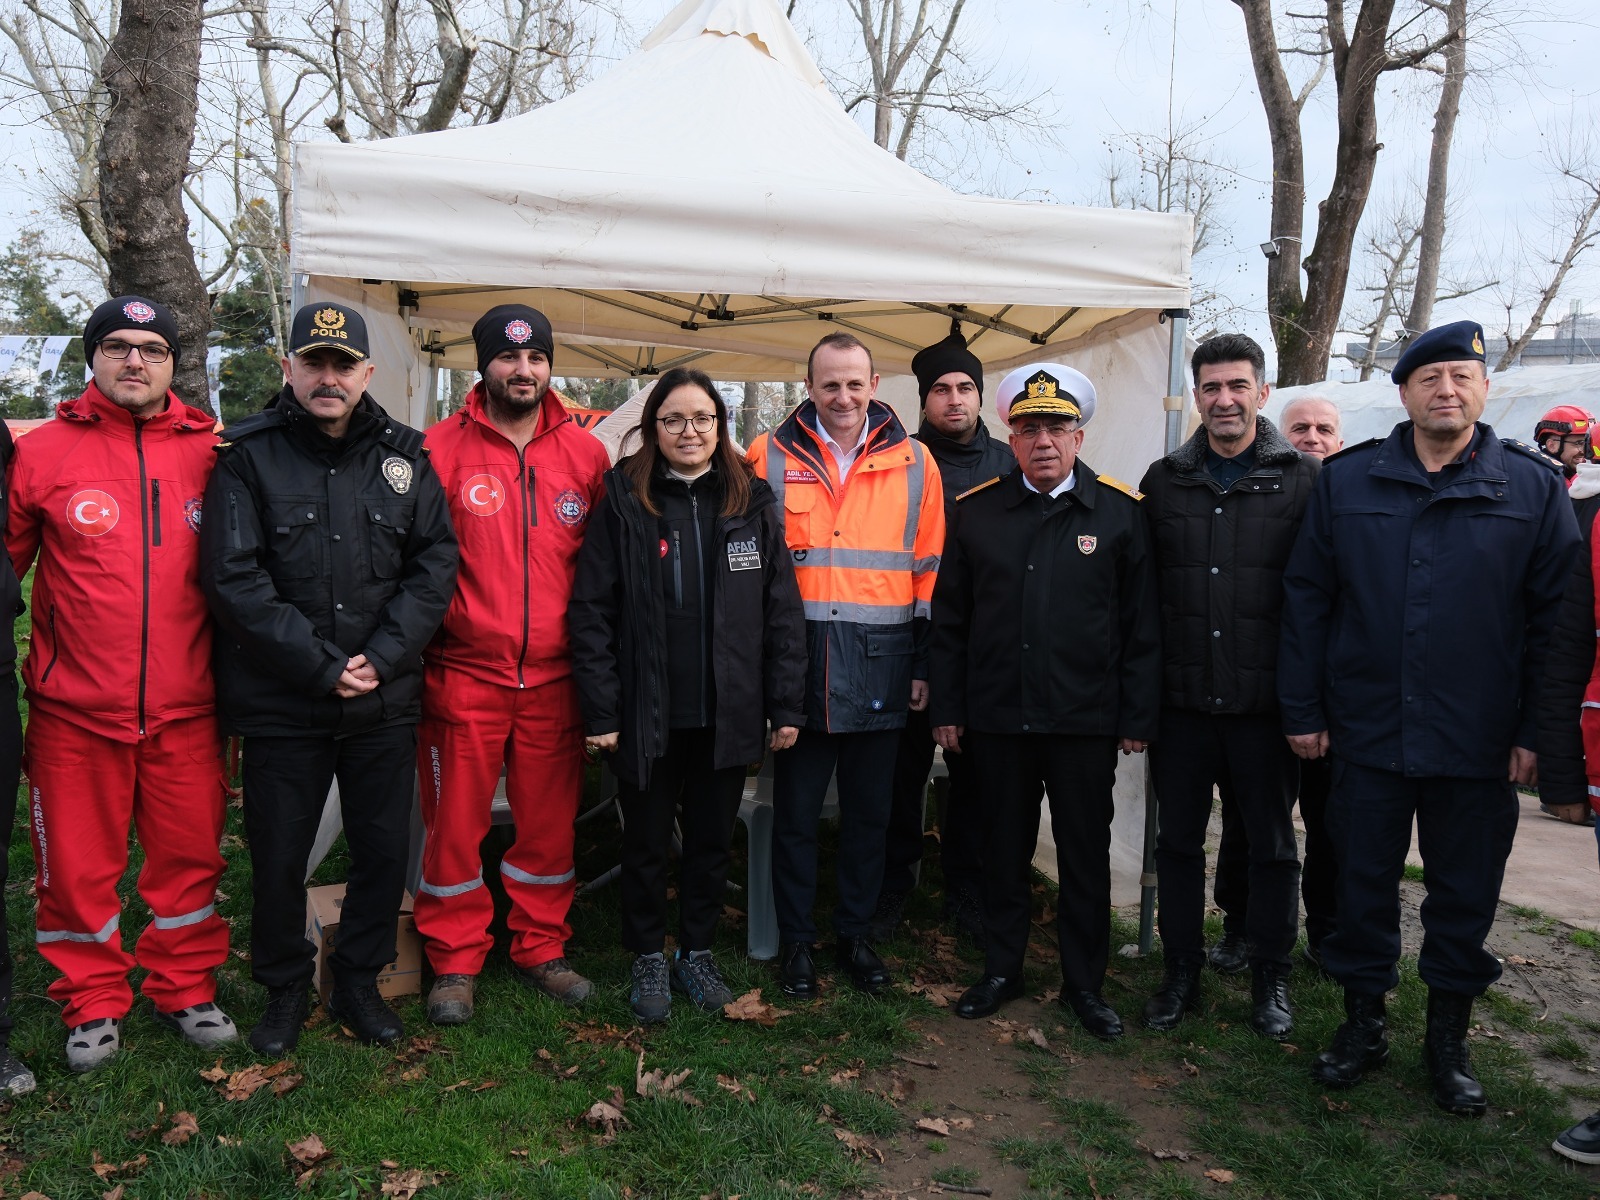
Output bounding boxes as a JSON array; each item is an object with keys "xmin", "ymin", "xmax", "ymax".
[{"xmin": 416, "ymin": 678, "xmax": 584, "ymax": 974}]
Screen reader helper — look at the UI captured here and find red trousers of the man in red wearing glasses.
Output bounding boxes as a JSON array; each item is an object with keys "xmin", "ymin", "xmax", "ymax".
[{"xmin": 24, "ymin": 709, "xmax": 229, "ymax": 1026}]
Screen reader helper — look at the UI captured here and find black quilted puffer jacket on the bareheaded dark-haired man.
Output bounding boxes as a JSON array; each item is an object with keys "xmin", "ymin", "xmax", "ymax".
[{"xmin": 1139, "ymin": 416, "xmax": 1322, "ymax": 714}]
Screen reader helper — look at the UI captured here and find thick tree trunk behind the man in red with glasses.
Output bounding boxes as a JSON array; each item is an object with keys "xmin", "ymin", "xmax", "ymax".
[{"xmin": 99, "ymin": 0, "xmax": 211, "ymax": 408}]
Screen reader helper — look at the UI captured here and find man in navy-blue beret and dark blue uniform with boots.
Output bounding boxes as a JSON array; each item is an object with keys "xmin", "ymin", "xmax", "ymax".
[{"xmin": 1278, "ymin": 322, "xmax": 1579, "ymax": 1115}]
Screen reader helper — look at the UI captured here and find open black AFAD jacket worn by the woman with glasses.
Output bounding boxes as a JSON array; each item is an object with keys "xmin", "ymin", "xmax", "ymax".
[{"xmin": 566, "ymin": 459, "xmax": 806, "ymax": 787}]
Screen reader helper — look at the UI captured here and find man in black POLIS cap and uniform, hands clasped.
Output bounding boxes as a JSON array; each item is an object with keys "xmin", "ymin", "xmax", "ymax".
[{"xmin": 200, "ymin": 304, "xmax": 456, "ymax": 1054}]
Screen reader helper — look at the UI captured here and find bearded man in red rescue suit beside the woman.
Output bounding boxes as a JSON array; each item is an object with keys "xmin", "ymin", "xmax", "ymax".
[{"xmin": 416, "ymin": 304, "xmax": 610, "ymax": 1024}]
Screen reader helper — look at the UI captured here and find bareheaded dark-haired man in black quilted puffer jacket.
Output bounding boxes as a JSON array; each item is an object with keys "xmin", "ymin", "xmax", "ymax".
[{"xmin": 1139, "ymin": 334, "xmax": 1320, "ymax": 1038}]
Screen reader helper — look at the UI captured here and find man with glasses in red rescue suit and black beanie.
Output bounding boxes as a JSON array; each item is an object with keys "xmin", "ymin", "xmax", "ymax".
[{"xmin": 6, "ymin": 296, "xmax": 238, "ymax": 1070}]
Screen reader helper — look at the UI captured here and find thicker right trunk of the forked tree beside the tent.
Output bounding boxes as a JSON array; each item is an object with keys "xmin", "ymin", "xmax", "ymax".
[{"xmin": 1278, "ymin": 0, "xmax": 1395, "ymax": 387}]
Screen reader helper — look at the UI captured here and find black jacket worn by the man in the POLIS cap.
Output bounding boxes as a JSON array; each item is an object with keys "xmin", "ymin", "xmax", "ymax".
[{"xmin": 200, "ymin": 387, "xmax": 456, "ymax": 736}]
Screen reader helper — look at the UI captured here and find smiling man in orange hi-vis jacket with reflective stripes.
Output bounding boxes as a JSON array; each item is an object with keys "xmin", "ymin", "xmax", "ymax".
[{"xmin": 749, "ymin": 333, "xmax": 944, "ymax": 997}]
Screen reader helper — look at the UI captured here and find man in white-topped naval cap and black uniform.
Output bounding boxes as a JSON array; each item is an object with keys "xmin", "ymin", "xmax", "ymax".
[{"xmin": 928, "ymin": 363, "xmax": 1162, "ymax": 1038}]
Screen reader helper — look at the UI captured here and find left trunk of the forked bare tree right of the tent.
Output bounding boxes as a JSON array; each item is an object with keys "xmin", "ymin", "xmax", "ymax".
[{"xmin": 1238, "ymin": 0, "xmax": 1306, "ymax": 384}]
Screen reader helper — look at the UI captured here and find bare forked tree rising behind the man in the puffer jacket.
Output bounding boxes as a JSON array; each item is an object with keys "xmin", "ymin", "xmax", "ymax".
[{"xmin": 1235, "ymin": 0, "xmax": 1461, "ymax": 386}]
